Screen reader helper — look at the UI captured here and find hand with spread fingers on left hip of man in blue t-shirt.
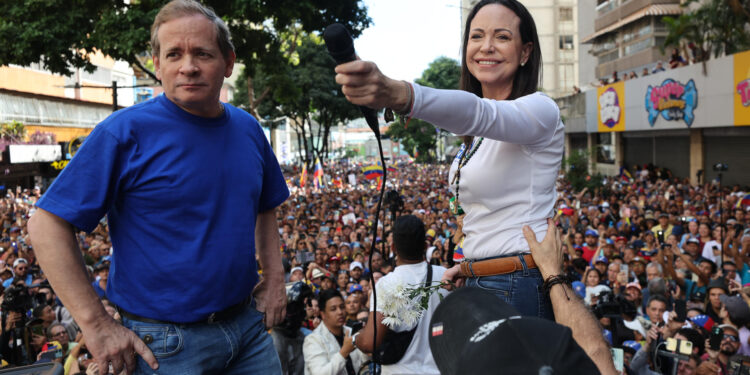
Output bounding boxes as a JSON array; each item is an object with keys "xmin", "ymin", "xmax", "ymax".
[{"xmin": 84, "ymin": 316, "xmax": 159, "ymax": 374}]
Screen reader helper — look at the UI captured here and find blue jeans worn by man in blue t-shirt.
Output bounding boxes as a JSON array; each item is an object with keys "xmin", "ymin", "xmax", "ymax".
[{"xmin": 122, "ymin": 304, "xmax": 281, "ymax": 375}]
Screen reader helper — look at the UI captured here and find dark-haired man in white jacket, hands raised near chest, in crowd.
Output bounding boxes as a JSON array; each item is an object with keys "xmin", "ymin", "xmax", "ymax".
[{"xmin": 302, "ymin": 289, "xmax": 367, "ymax": 375}]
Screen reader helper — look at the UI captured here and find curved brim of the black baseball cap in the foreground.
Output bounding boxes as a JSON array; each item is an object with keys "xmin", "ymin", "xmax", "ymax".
[{"xmin": 428, "ymin": 287, "xmax": 520, "ymax": 374}]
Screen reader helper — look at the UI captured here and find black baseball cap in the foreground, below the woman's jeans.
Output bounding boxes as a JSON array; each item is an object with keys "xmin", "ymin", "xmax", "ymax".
[{"xmin": 430, "ymin": 287, "xmax": 599, "ymax": 375}]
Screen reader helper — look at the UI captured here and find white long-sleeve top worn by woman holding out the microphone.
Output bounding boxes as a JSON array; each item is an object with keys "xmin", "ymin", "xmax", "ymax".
[{"xmin": 411, "ymin": 84, "xmax": 564, "ymax": 259}]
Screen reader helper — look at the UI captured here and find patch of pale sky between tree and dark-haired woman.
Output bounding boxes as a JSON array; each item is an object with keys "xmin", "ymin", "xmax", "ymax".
[{"xmin": 354, "ymin": 0, "xmax": 461, "ymax": 81}]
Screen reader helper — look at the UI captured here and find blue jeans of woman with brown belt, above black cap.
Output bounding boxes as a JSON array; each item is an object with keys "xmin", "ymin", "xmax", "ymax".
[{"xmin": 466, "ymin": 255, "xmax": 555, "ymax": 321}]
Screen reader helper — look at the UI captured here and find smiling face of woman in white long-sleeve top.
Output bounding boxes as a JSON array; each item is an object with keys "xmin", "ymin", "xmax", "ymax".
[{"xmin": 465, "ymin": 4, "xmax": 532, "ymax": 99}]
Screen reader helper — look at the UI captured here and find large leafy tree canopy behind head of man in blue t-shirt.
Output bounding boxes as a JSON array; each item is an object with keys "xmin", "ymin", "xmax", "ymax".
[{"xmin": 0, "ymin": 0, "xmax": 370, "ymax": 112}]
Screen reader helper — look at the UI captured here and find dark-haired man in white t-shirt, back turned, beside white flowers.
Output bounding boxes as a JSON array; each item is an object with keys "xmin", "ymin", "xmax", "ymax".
[{"xmin": 354, "ymin": 215, "xmax": 447, "ymax": 375}]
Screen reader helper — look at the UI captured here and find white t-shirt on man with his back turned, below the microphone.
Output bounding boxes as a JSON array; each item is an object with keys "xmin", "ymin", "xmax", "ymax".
[{"xmin": 370, "ymin": 262, "xmax": 448, "ymax": 375}]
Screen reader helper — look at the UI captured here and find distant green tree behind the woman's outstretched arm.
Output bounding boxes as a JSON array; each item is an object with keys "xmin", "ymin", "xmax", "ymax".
[{"xmin": 386, "ymin": 56, "xmax": 461, "ymax": 162}]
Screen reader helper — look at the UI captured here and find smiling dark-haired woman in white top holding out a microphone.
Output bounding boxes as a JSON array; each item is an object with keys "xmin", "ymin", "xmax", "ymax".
[{"xmin": 336, "ymin": 0, "xmax": 564, "ymax": 319}]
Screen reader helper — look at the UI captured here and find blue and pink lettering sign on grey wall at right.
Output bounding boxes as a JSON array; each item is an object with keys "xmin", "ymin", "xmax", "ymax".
[{"xmin": 645, "ymin": 78, "xmax": 698, "ymax": 127}]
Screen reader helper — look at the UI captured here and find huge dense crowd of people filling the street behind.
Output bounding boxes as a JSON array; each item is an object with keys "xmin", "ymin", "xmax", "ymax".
[{"xmin": 0, "ymin": 161, "xmax": 750, "ymax": 374}]
